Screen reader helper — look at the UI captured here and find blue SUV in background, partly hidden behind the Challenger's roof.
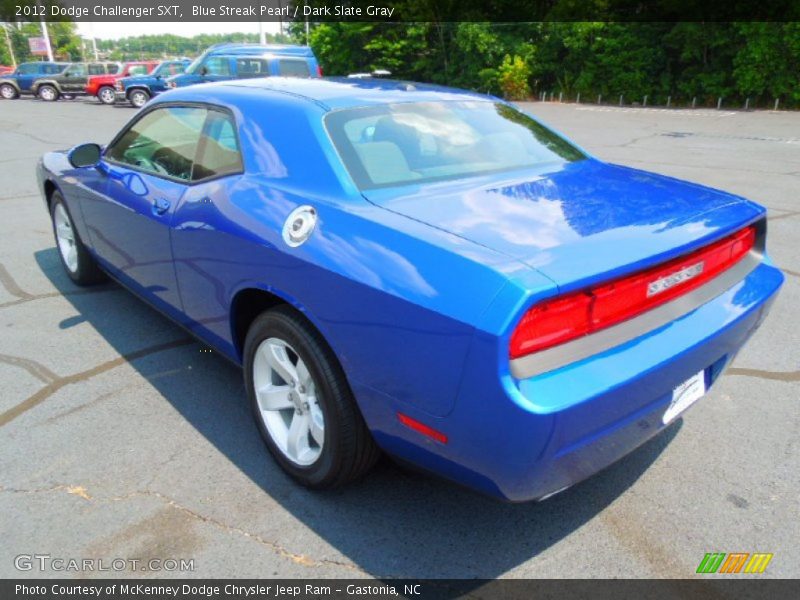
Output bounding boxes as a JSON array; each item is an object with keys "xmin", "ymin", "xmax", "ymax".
[{"xmin": 167, "ymin": 44, "xmax": 322, "ymax": 88}]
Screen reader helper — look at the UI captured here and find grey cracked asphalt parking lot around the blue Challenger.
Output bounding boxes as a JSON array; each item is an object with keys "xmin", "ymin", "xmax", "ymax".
[{"xmin": 0, "ymin": 99, "xmax": 800, "ymax": 578}]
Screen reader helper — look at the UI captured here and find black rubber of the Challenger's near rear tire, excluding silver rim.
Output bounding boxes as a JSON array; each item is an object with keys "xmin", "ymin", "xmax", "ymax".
[{"xmin": 244, "ymin": 305, "xmax": 380, "ymax": 489}]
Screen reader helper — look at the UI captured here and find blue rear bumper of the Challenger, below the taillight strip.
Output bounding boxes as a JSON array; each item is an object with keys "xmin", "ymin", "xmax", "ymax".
[{"xmin": 366, "ymin": 262, "xmax": 783, "ymax": 502}]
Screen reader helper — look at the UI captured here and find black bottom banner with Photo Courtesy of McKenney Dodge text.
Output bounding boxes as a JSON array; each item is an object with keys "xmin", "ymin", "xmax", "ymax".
[{"xmin": 0, "ymin": 575, "xmax": 800, "ymax": 600}]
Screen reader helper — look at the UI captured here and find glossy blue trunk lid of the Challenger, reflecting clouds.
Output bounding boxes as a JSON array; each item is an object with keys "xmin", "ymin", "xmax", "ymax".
[{"xmin": 364, "ymin": 159, "xmax": 764, "ymax": 291}]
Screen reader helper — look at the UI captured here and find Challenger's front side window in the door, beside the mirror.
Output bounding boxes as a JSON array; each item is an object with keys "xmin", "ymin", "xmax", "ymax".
[{"xmin": 105, "ymin": 106, "xmax": 209, "ymax": 181}]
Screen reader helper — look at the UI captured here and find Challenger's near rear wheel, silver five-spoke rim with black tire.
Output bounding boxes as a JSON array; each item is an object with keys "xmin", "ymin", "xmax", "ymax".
[{"xmin": 244, "ymin": 306, "xmax": 379, "ymax": 489}]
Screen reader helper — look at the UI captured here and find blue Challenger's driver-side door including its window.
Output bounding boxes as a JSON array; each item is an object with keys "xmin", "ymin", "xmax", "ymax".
[{"xmin": 79, "ymin": 105, "xmax": 208, "ymax": 318}]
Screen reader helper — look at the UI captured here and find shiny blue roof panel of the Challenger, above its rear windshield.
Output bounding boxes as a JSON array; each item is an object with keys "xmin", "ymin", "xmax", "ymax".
[{"xmin": 212, "ymin": 77, "xmax": 497, "ymax": 110}]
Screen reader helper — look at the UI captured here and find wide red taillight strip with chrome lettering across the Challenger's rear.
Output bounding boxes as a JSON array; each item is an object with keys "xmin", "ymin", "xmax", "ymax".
[{"xmin": 509, "ymin": 226, "xmax": 756, "ymax": 358}]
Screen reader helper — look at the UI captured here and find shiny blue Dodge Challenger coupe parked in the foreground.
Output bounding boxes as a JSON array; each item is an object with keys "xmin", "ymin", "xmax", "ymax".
[{"xmin": 38, "ymin": 78, "xmax": 783, "ymax": 501}]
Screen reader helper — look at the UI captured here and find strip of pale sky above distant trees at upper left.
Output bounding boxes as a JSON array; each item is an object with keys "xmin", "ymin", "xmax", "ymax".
[{"xmin": 77, "ymin": 21, "xmax": 279, "ymax": 40}]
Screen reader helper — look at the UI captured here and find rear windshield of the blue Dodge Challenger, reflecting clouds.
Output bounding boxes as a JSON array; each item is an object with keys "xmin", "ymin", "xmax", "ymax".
[{"xmin": 325, "ymin": 101, "xmax": 586, "ymax": 189}]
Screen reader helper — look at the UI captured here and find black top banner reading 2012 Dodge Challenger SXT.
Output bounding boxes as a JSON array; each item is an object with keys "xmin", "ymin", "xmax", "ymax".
[{"xmin": 0, "ymin": 0, "xmax": 800, "ymax": 23}]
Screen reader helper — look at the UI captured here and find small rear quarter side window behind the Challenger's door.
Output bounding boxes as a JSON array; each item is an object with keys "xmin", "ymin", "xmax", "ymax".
[{"xmin": 192, "ymin": 110, "xmax": 243, "ymax": 181}]
